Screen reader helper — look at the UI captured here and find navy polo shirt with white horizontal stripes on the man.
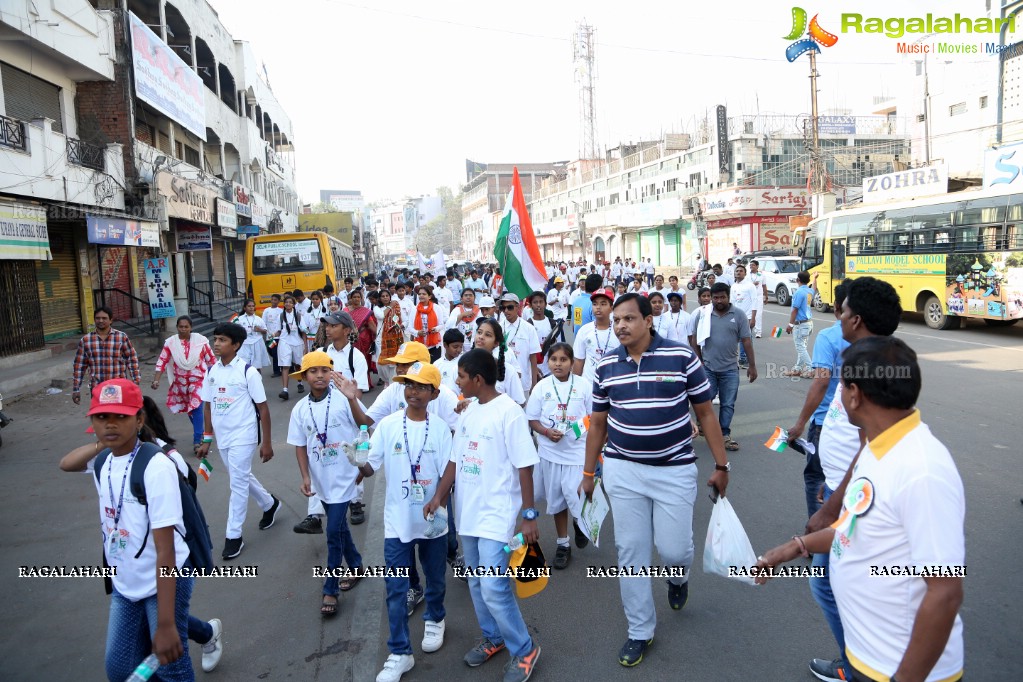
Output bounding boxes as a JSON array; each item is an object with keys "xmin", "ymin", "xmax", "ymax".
[{"xmin": 593, "ymin": 334, "xmax": 714, "ymax": 466}]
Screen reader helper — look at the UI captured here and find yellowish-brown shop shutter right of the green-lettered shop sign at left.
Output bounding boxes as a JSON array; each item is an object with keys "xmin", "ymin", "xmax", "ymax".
[{"xmin": 36, "ymin": 223, "xmax": 82, "ymax": 340}]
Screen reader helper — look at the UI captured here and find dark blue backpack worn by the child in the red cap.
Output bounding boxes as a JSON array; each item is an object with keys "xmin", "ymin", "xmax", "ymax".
[{"xmin": 93, "ymin": 443, "xmax": 214, "ymax": 594}]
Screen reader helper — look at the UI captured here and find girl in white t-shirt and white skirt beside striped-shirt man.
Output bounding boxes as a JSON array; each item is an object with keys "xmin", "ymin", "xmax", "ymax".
[{"xmin": 526, "ymin": 344, "xmax": 593, "ymax": 569}]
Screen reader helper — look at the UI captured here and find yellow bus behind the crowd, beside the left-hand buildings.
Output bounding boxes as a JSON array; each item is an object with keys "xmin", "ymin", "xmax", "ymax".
[{"xmin": 246, "ymin": 232, "xmax": 355, "ymax": 311}]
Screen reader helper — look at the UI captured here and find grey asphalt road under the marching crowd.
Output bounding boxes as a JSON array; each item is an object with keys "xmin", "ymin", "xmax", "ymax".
[{"xmin": 0, "ymin": 304, "xmax": 1023, "ymax": 682}]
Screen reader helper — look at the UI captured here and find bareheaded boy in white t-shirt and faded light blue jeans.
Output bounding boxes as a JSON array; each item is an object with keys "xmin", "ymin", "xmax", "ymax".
[{"xmin": 424, "ymin": 349, "xmax": 540, "ymax": 682}]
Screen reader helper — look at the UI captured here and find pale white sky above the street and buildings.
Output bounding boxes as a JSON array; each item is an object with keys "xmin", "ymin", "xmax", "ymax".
[{"xmin": 210, "ymin": 0, "xmax": 1006, "ymax": 202}]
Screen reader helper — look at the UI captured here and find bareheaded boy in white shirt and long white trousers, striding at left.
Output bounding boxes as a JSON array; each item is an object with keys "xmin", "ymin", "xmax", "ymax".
[{"xmin": 195, "ymin": 323, "xmax": 280, "ymax": 560}]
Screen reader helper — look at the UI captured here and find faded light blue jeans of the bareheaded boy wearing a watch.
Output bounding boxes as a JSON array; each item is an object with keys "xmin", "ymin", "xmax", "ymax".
[{"xmin": 461, "ymin": 535, "xmax": 533, "ymax": 656}]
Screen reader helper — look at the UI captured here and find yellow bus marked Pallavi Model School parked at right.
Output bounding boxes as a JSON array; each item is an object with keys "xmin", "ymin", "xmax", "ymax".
[{"xmin": 800, "ymin": 189, "xmax": 1023, "ymax": 329}]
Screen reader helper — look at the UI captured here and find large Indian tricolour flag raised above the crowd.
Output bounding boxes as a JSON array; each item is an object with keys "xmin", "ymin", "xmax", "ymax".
[{"xmin": 494, "ymin": 168, "xmax": 547, "ymax": 299}]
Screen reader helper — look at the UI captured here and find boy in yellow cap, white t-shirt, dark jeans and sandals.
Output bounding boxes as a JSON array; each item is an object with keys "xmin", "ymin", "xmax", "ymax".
[{"xmin": 287, "ymin": 351, "xmax": 368, "ymax": 618}]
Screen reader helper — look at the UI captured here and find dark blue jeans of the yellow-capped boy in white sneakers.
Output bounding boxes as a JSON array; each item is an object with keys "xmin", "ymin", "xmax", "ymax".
[{"xmin": 384, "ymin": 538, "xmax": 447, "ymax": 653}]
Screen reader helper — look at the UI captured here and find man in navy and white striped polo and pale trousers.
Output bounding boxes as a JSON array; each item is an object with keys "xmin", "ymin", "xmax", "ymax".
[{"xmin": 582, "ymin": 293, "xmax": 729, "ymax": 667}]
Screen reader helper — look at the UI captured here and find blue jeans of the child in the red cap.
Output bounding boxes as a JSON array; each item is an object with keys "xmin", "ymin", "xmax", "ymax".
[{"xmin": 104, "ymin": 578, "xmax": 195, "ymax": 682}]
